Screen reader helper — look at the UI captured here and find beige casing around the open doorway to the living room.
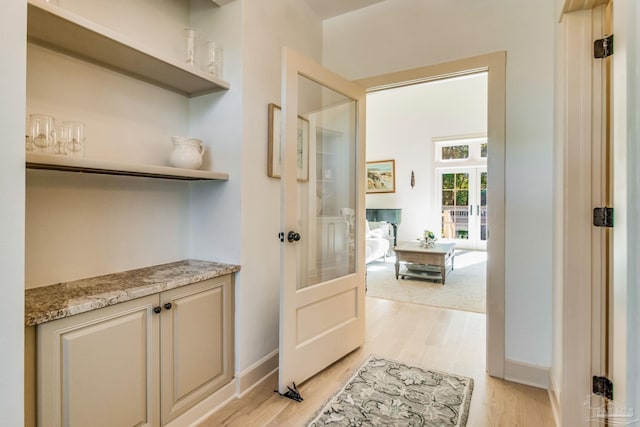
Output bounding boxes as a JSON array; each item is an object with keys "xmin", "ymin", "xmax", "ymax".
[{"xmin": 356, "ymin": 52, "xmax": 506, "ymax": 378}]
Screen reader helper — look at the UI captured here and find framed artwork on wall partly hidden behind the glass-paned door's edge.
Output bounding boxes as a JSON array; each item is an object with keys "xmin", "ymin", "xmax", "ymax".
[{"xmin": 267, "ymin": 104, "xmax": 309, "ymax": 182}]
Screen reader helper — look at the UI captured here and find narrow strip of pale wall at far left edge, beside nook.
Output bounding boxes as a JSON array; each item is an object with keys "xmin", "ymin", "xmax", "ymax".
[{"xmin": 0, "ymin": 0, "xmax": 27, "ymax": 426}]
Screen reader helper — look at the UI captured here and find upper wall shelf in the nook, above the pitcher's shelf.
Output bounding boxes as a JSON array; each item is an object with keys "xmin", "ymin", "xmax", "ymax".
[{"xmin": 27, "ymin": 0, "xmax": 229, "ymax": 97}]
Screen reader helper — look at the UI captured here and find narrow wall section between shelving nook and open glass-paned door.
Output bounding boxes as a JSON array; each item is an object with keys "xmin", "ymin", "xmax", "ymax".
[{"xmin": 236, "ymin": 0, "xmax": 322, "ymax": 369}]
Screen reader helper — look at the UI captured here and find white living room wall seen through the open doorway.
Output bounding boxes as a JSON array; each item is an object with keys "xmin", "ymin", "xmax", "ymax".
[{"xmin": 367, "ymin": 74, "xmax": 487, "ymax": 244}]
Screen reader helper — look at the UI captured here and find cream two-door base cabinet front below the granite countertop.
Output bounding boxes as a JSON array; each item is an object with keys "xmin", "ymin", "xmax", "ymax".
[{"xmin": 37, "ymin": 275, "xmax": 233, "ymax": 427}]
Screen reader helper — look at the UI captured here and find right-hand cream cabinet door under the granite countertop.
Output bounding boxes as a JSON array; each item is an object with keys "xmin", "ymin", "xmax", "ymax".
[{"xmin": 160, "ymin": 276, "xmax": 233, "ymax": 424}]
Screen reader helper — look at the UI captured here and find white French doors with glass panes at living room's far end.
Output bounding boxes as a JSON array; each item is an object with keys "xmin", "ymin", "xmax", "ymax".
[{"xmin": 437, "ymin": 166, "xmax": 488, "ymax": 250}]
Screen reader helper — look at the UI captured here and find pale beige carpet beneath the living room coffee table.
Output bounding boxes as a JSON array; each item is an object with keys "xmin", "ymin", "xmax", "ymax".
[{"xmin": 367, "ymin": 250, "xmax": 487, "ymax": 313}]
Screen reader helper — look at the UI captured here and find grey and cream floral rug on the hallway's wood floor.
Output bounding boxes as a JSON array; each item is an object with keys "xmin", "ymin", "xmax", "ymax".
[{"xmin": 307, "ymin": 355, "xmax": 473, "ymax": 427}]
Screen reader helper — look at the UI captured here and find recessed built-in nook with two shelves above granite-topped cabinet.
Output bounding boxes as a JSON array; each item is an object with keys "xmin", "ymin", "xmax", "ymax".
[{"xmin": 24, "ymin": 0, "xmax": 239, "ymax": 426}]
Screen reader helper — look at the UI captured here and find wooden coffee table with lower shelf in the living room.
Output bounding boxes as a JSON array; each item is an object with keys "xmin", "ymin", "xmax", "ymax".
[{"xmin": 393, "ymin": 242, "xmax": 456, "ymax": 285}]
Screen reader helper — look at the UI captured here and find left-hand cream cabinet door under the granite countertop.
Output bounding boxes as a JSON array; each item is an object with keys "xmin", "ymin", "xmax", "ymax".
[{"xmin": 37, "ymin": 295, "xmax": 159, "ymax": 427}]
